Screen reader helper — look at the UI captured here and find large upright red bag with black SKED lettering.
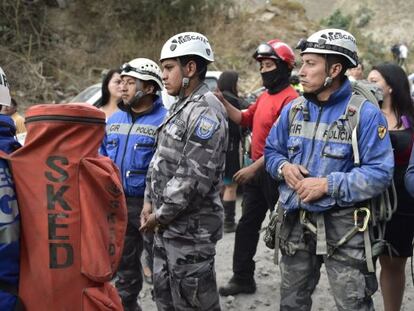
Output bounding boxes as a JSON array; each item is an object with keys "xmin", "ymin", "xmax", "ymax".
[{"xmin": 5, "ymin": 104, "xmax": 127, "ymax": 311}]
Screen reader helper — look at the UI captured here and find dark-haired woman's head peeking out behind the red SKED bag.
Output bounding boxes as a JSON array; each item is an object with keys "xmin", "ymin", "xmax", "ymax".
[{"xmin": 96, "ymin": 69, "xmax": 122, "ymax": 120}]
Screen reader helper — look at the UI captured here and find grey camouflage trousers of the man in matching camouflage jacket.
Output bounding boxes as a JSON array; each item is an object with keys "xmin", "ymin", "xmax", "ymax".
[{"xmin": 153, "ymin": 233, "xmax": 220, "ymax": 311}]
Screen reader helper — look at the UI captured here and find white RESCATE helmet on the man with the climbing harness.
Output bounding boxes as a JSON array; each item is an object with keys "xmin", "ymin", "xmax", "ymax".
[{"xmin": 296, "ymin": 29, "xmax": 358, "ymax": 68}]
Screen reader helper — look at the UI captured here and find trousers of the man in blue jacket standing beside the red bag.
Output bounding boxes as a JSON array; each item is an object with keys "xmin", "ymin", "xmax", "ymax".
[{"xmin": 115, "ymin": 197, "xmax": 144, "ymax": 311}]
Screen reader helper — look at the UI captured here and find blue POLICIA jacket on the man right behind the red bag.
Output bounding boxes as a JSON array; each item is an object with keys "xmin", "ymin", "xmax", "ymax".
[{"xmin": 101, "ymin": 97, "xmax": 167, "ymax": 197}]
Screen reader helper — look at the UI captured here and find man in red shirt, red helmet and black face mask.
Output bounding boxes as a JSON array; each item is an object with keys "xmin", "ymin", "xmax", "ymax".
[{"xmin": 217, "ymin": 39, "xmax": 298, "ymax": 296}]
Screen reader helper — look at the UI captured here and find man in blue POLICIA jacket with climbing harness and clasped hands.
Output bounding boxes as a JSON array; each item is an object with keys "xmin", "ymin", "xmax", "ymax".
[{"xmin": 265, "ymin": 29, "xmax": 394, "ymax": 310}]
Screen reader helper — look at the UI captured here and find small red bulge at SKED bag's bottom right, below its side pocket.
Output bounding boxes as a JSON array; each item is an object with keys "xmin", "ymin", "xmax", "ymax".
[{"xmin": 82, "ymin": 283, "xmax": 123, "ymax": 311}]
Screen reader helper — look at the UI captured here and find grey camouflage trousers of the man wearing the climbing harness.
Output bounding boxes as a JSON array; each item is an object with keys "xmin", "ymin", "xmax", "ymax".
[{"xmin": 280, "ymin": 208, "xmax": 378, "ymax": 311}]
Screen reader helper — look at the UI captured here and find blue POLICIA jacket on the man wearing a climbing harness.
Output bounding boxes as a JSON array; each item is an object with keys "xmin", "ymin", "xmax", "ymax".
[{"xmin": 264, "ymin": 80, "xmax": 394, "ymax": 212}]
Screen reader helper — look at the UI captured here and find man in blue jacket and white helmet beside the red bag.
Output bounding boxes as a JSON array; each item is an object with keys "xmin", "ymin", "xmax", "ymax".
[{"xmin": 101, "ymin": 58, "xmax": 167, "ymax": 311}]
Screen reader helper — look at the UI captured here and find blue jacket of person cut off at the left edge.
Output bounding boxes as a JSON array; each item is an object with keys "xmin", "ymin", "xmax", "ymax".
[{"xmin": 0, "ymin": 115, "xmax": 20, "ymax": 311}]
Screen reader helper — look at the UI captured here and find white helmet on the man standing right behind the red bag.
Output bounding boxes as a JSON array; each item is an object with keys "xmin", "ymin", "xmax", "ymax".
[{"xmin": 121, "ymin": 58, "xmax": 163, "ymax": 90}]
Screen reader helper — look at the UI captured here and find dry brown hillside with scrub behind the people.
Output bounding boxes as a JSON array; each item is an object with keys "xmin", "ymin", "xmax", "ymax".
[{"xmin": 0, "ymin": 0, "xmax": 414, "ymax": 110}]
